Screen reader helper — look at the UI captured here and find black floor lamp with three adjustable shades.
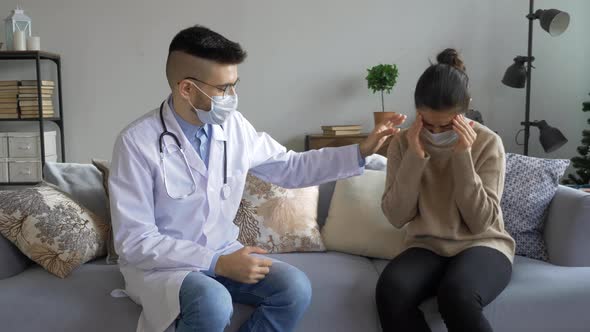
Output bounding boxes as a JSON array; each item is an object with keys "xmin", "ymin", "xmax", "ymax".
[{"xmin": 502, "ymin": 0, "xmax": 570, "ymax": 156}]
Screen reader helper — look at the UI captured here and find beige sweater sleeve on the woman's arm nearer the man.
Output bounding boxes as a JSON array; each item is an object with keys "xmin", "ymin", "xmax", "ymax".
[{"xmin": 381, "ymin": 134, "xmax": 430, "ymax": 228}]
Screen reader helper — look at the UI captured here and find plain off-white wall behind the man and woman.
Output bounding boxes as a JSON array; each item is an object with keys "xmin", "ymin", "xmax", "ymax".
[{"xmin": 0, "ymin": 0, "xmax": 590, "ymax": 166}]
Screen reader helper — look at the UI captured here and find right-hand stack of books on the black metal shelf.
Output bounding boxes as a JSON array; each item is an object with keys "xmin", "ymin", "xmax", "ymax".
[{"xmin": 18, "ymin": 81, "xmax": 55, "ymax": 119}]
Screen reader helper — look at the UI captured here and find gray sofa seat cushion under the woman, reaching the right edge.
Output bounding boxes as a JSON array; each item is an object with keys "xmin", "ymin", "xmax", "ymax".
[{"xmin": 373, "ymin": 256, "xmax": 590, "ymax": 332}]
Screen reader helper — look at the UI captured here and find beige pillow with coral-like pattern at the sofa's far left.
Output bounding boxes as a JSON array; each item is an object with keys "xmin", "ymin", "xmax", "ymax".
[{"xmin": 0, "ymin": 183, "xmax": 109, "ymax": 278}]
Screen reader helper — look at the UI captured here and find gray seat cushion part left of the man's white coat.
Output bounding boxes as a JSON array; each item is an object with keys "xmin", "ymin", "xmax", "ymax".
[{"xmin": 0, "ymin": 259, "xmax": 141, "ymax": 332}]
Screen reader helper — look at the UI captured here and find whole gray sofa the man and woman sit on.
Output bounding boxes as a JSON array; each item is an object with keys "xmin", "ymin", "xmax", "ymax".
[{"xmin": 0, "ymin": 170, "xmax": 590, "ymax": 332}]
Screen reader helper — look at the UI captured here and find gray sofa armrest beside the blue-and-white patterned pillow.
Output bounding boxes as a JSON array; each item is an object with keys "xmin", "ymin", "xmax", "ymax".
[{"xmin": 544, "ymin": 186, "xmax": 590, "ymax": 266}]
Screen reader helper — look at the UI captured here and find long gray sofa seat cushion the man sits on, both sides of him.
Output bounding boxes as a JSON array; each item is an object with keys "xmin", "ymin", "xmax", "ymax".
[{"xmin": 0, "ymin": 252, "xmax": 380, "ymax": 332}]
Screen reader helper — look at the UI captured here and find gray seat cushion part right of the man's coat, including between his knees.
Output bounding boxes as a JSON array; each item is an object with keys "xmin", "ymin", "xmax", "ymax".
[{"xmin": 226, "ymin": 252, "xmax": 380, "ymax": 332}]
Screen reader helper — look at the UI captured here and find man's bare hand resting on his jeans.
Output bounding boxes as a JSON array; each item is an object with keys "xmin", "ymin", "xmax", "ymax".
[{"xmin": 215, "ymin": 247, "xmax": 272, "ymax": 284}]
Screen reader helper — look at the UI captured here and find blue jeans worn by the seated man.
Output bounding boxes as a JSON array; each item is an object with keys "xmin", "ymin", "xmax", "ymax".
[{"xmin": 176, "ymin": 260, "xmax": 311, "ymax": 332}]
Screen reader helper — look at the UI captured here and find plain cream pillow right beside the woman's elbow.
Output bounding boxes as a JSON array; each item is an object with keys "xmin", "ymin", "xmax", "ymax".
[{"xmin": 322, "ymin": 170, "xmax": 405, "ymax": 259}]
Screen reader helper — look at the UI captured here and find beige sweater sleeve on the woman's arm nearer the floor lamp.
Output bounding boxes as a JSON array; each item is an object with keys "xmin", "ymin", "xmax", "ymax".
[{"xmin": 451, "ymin": 137, "xmax": 506, "ymax": 234}]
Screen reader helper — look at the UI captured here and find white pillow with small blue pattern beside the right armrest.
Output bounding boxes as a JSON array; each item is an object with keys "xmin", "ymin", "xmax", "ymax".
[{"xmin": 501, "ymin": 153, "xmax": 569, "ymax": 261}]
